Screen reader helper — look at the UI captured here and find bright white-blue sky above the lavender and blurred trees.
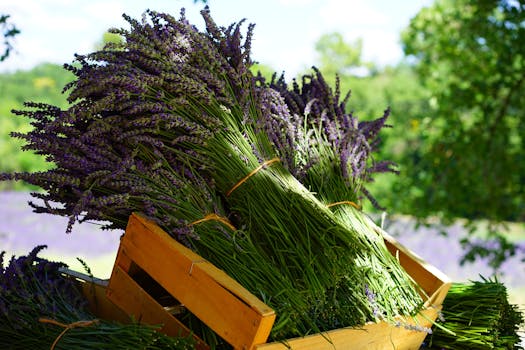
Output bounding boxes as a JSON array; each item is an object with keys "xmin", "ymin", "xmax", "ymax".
[{"xmin": 0, "ymin": 0, "xmax": 432, "ymax": 75}]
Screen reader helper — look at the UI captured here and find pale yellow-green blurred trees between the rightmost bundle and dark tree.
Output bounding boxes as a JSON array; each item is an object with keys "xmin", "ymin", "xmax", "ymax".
[{"xmin": 315, "ymin": 33, "xmax": 429, "ymax": 211}]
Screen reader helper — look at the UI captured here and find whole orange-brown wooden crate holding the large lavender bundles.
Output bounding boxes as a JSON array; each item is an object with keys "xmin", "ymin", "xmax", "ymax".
[{"xmin": 103, "ymin": 213, "xmax": 451, "ymax": 350}]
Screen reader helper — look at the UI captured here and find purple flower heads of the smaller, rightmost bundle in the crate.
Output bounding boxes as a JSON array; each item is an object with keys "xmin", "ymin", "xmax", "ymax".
[{"xmin": 257, "ymin": 68, "xmax": 397, "ymax": 208}]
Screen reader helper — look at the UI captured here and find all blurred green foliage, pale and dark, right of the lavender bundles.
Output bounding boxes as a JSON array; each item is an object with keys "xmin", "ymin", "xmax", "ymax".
[{"xmin": 310, "ymin": 0, "xmax": 525, "ymax": 268}]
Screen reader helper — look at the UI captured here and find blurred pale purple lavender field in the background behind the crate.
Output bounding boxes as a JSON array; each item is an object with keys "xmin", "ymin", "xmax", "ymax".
[{"xmin": 0, "ymin": 192, "xmax": 525, "ymax": 316}]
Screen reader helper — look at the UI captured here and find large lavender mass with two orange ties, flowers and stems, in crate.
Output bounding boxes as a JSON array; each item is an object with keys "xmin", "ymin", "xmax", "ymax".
[{"xmin": 2, "ymin": 10, "xmax": 426, "ymax": 339}]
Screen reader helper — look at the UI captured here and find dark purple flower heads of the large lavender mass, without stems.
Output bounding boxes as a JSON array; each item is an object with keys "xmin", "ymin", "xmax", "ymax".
[{"xmin": 0, "ymin": 8, "xmax": 253, "ymax": 236}]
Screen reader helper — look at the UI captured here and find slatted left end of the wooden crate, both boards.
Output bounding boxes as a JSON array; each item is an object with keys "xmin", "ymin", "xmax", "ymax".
[{"xmin": 107, "ymin": 214, "xmax": 275, "ymax": 349}]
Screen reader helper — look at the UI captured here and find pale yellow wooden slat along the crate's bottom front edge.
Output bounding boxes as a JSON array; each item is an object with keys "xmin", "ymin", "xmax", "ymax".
[{"xmin": 256, "ymin": 308, "xmax": 437, "ymax": 350}]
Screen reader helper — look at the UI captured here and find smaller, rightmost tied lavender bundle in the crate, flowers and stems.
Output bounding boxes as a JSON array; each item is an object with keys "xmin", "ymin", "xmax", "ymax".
[{"xmin": 258, "ymin": 68, "xmax": 421, "ymax": 319}]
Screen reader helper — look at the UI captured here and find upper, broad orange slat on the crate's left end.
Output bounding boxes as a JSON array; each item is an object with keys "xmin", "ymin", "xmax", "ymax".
[{"xmin": 112, "ymin": 214, "xmax": 275, "ymax": 349}]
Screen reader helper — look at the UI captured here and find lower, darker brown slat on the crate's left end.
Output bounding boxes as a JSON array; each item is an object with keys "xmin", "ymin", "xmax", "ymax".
[{"xmin": 106, "ymin": 266, "xmax": 209, "ymax": 350}]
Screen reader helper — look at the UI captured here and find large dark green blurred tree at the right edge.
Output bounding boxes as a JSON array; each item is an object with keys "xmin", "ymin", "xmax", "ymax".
[{"xmin": 402, "ymin": 0, "xmax": 525, "ymax": 266}]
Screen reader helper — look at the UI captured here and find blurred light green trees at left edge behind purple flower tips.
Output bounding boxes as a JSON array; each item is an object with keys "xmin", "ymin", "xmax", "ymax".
[{"xmin": 0, "ymin": 64, "xmax": 73, "ymax": 190}]
